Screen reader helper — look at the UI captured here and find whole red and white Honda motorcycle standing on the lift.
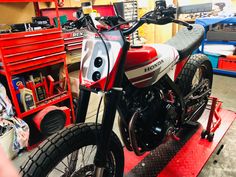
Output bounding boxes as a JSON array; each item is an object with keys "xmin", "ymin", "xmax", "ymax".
[{"xmin": 21, "ymin": 0, "xmax": 213, "ymax": 177}]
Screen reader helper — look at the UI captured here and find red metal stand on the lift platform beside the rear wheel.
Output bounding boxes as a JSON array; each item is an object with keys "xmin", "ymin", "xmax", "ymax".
[{"xmin": 201, "ymin": 97, "xmax": 222, "ymax": 142}]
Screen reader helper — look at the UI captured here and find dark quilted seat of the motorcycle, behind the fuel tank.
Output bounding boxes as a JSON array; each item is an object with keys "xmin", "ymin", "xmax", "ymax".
[{"xmin": 166, "ymin": 24, "xmax": 205, "ymax": 59}]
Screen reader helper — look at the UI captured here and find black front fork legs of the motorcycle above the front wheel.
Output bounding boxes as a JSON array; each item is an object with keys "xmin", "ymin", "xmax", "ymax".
[{"xmin": 76, "ymin": 89, "xmax": 122, "ymax": 177}]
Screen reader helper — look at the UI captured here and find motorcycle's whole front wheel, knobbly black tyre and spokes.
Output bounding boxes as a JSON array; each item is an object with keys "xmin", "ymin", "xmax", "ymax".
[{"xmin": 20, "ymin": 124, "xmax": 124, "ymax": 177}]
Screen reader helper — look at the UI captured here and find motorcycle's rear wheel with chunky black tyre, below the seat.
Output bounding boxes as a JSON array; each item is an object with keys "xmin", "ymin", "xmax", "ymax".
[{"xmin": 178, "ymin": 54, "xmax": 213, "ymax": 118}]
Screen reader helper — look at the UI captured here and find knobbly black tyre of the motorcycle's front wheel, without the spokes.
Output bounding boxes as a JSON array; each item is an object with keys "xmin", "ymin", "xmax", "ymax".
[{"xmin": 20, "ymin": 123, "xmax": 124, "ymax": 177}]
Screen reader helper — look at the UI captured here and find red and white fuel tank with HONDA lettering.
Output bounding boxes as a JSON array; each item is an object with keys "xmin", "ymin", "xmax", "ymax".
[{"xmin": 125, "ymin": 44, "xmax": 179, "ymax": 88}]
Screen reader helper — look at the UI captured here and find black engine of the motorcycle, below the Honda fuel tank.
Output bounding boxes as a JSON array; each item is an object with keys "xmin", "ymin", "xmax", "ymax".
[{"xmin": 119, "ymin": 81, "xmax": 178, "ymax": 151}]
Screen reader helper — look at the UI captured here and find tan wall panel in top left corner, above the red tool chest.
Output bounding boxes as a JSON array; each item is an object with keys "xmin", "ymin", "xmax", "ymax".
[{"xmin": 0, "ymin": 3, "xmax": 35, "ymax": 24}]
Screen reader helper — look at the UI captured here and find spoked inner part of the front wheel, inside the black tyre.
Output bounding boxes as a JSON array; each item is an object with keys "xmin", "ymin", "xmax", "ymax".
[{"xmin": 48, "ymin": 145, "xmax": 116, "ymax": 177}]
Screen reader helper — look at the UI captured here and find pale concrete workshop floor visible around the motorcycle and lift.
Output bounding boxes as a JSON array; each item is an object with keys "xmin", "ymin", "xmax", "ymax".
[{"xmin": 13, "ymin": 75, "xmax": 236, "ymax": 177}]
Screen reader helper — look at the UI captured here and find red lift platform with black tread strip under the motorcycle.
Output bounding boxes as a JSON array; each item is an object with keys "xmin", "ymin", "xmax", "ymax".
[{"xmin": 125, "ymin": 108, "xmax": 236, "ymax": 177}]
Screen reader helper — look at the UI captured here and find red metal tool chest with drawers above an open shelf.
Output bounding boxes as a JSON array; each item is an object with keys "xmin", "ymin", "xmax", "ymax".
[{"xmin": 0, "ymin": 0, "xmax": 75, "ymax": 123}]
